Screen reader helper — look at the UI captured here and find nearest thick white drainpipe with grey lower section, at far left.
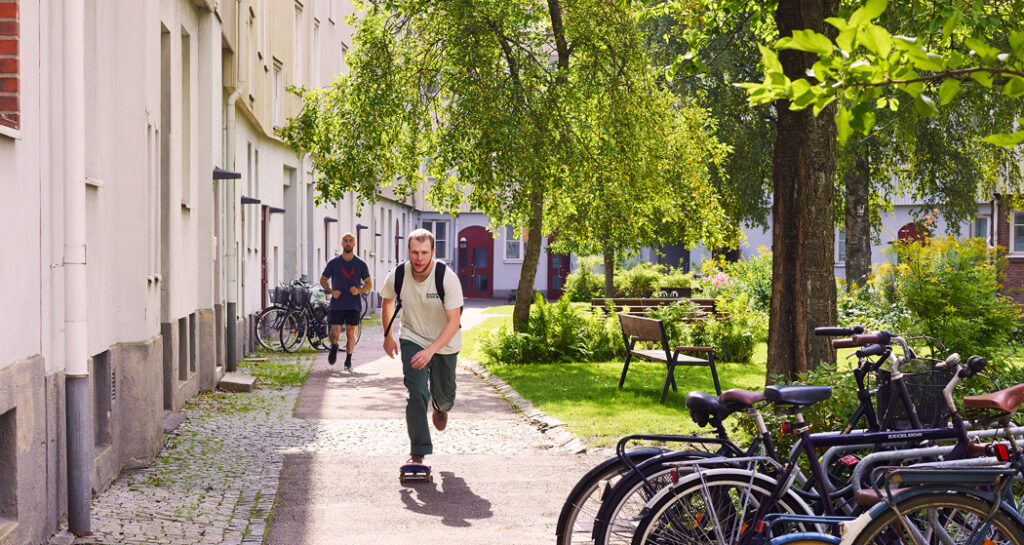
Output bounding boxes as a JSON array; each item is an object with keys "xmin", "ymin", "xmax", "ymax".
[{"xmin": 63, "ymin": 1, "xmax": 92, "ymax": 535}]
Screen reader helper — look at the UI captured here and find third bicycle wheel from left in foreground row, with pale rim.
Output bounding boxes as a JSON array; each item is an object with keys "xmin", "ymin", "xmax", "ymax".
[{"xmin": 633, "ymin": 469, "xmax": 810, "ymax": 545}]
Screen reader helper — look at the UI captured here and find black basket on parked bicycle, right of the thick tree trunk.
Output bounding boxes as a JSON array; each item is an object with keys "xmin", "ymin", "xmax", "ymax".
[{"xmin": 874, "ymin": 369, "xmax": 950, "ymax": 430}]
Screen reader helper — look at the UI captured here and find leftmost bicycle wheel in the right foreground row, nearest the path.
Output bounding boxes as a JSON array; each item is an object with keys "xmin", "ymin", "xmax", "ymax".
[{"xmin": 555, "ymin": 449, "xmax": 664, "ymax": 545}]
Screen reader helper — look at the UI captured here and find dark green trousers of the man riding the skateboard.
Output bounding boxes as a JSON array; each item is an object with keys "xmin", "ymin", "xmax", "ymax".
[{"xmin": 400, "ymin": 340, "xmax": 459, "ymax": 456}]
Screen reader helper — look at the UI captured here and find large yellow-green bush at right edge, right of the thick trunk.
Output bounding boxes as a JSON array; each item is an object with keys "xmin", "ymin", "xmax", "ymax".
[{"xmin": 839, "ymin": 237, "xmax": 1020, "ymax": 359}]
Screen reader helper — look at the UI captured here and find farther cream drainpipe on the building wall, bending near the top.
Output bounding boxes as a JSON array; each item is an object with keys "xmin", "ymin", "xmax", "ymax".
[{"xmin": 224, "ymin": 0, "xmax": 249, "ymax": 371}]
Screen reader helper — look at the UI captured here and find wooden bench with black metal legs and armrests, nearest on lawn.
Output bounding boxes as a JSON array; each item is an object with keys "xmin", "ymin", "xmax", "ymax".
[{"xmin": 618, "ymin": 313, "xmax": 722, "ymax": 405}]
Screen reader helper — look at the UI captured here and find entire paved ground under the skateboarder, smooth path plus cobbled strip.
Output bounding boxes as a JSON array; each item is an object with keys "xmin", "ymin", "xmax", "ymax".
[{"xmin": 76, "ymin": 305, "xmax": 595, "ymax": 545}]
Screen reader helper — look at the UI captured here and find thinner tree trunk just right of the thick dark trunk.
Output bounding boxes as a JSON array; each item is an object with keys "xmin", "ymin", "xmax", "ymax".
[{"xmin": 846, "ymin": 152, "xmax": 871, "ymax": 287}]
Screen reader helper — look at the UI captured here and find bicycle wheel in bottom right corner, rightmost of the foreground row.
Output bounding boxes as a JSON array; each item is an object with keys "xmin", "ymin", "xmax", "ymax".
[{"xmin": 853, "ymin": 492, "xmax": 1024, "ymax": 545}]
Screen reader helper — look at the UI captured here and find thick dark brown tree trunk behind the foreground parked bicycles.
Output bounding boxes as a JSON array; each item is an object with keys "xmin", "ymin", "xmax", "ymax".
[{"xmin": 767, "ymin": 0, "xmax": 839, "ymax": 382}]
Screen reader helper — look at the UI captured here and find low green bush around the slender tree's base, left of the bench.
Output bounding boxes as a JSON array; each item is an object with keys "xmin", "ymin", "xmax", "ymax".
[{"xmin": 481, "ymin": 290, "xmax": 626, "ymax": 364}]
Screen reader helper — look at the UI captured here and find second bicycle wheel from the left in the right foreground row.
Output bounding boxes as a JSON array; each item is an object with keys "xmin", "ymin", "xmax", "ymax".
[{"xmin": 594, "ymin": 451, "xmax": 718, "ymax": 545}]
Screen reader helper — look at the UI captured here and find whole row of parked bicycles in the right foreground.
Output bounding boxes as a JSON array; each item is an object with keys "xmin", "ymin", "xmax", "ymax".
[{"xmin": 556, "ymin": 327, "xmax": 1024, "ymax": 545}]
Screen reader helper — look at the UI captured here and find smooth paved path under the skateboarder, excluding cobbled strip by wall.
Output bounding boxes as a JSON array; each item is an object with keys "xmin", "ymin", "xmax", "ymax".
[{"xmin": 265, "ymin": 306, "xmax": 595, "ymax": 545}]
